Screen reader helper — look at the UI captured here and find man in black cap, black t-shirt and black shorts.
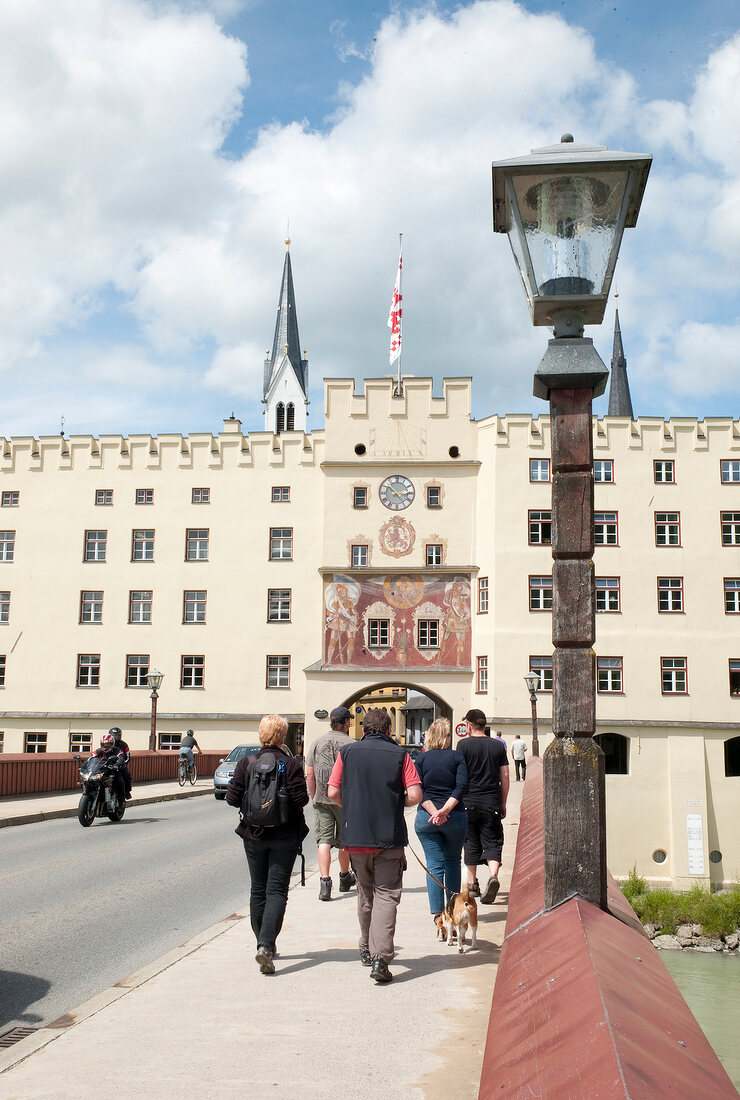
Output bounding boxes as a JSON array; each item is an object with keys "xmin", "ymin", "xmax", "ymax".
[{"xmin": 457, "ymin": 710, "xmax": 509, "ymax": 905}]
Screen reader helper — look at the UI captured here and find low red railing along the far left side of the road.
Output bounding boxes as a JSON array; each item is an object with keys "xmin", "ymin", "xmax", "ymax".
[{"xmin": 0, "ymin": 749, "xmax": 228, "ymax": 798}]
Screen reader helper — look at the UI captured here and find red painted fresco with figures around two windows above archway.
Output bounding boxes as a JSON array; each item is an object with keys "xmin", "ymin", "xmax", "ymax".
[{"xmin": 324, "ymin": 573, "xmax": 471, "ymax": 669}]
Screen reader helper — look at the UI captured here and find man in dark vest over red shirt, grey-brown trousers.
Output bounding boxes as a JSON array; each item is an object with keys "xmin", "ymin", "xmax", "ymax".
[{"xmin": 328, "ymin": 707, "xmax": 421, "ymax": 982}]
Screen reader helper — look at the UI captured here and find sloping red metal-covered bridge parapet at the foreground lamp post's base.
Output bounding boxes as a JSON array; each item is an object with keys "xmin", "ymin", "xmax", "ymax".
[{"xmin": 479, "ymin": 759, "xmax": 738, "ymax": 1100}]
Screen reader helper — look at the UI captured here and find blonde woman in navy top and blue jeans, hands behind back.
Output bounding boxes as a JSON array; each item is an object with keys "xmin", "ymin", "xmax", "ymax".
[{"xmin": 413, "ymin": 718, "xmax": 467, "ymax": 921}]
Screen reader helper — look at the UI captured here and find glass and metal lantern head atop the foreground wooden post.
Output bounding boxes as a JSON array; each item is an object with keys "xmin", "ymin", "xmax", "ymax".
[{"xmin": 493, "ymin": 134, "xmax": 652, "ymax": 325}]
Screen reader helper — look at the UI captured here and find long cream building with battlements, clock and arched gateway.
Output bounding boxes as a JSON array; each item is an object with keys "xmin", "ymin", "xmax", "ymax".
[{"xmin": 0, "ymin": 253, "xmax": 740, "ymax": 886}]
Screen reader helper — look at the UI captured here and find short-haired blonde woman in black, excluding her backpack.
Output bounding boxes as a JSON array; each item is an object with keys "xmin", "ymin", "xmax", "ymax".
[{"xmin": 227, "ymin": 714, "xmax": 308, "ymax": 974}]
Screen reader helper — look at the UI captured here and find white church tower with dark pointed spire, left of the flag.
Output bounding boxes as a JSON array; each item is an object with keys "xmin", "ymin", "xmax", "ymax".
[{"xmin": 263, "ymin": 238, "xmax": 308, "ymax": 432}]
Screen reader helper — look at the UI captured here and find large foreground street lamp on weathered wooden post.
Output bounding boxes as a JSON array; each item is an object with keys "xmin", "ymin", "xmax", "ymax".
[{"xmin": 493, "ymin": 134, "xmax": 652, "ymax": 909}]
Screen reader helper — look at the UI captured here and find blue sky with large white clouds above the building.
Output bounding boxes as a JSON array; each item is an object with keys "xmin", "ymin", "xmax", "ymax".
[{"xmin": 0, "ymin": 0, "xmax": 740, "ymax": 438}]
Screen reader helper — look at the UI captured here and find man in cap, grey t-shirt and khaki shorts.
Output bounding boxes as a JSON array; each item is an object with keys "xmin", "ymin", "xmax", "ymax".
[{"xmin": 306, "ymin": 706, "xmax": 355, "ymax": 901}]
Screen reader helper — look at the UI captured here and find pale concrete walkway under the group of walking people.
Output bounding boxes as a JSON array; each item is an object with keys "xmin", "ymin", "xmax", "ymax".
[{"xmin": 0, "ymin": 782, "xmax": 523, "ymax": 1100}]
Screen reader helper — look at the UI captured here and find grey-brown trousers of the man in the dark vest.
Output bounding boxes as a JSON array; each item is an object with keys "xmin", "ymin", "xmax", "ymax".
[{"xmin": 350, "ymin": 848, "xmax": 406, "ymax": 963}]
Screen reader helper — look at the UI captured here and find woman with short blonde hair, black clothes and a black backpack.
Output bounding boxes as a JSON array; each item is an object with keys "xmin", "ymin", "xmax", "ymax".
[{"xmin": 227, "ymin": 714, "xmax": 308, "ymax": 974}]
